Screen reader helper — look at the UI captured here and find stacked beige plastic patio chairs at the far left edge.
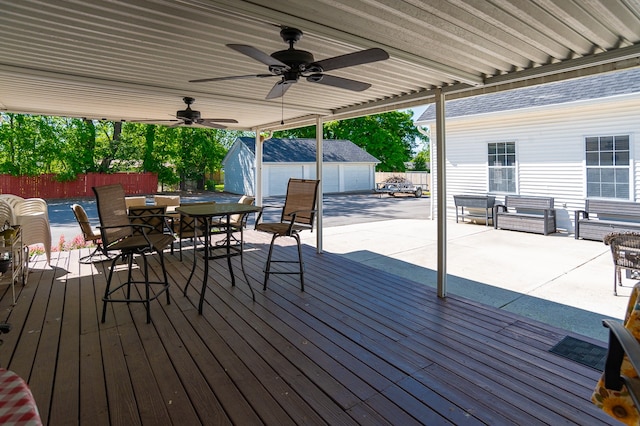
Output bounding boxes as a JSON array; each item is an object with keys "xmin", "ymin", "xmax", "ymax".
[{"xmin": 0, "ymin": 194, "xmax": 51, "ymax": 264}]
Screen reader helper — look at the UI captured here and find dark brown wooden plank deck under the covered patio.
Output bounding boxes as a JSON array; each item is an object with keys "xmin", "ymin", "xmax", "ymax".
[{"xmin": 0, "ymin": 231, "xmax": 613, "ymax": 426}]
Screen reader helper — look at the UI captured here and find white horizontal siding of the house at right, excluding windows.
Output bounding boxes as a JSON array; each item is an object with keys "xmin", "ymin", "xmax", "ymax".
[{"xmin": 424, "ymin": 94, "xmax": 640, "ymax": 232}]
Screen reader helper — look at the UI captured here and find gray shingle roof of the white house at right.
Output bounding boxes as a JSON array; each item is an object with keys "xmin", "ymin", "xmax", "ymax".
[{"xmin": 417, "ymin": 68, "xmax": 640, "ymax": 122}]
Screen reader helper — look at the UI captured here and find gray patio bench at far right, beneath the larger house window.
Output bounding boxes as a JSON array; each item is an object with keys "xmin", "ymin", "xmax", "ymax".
[{"xmin": 575, "ymin": 199, "xmax": 640, "ymax": 241}]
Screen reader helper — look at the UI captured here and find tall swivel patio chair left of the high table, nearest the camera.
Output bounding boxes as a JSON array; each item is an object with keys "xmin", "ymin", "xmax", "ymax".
[{"xmin": 93, "ymin": 184, "xmax": 173, "ymax": 323}]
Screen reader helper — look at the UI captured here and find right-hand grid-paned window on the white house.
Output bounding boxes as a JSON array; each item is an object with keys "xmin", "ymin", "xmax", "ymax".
[{"xmin": 585, "ymin": 135, "xmax": 630, "ymax": 200}]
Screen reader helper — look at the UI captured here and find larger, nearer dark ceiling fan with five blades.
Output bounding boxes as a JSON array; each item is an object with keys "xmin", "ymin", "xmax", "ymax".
[{"xmin": 189, "ymin": 27, "xmax": 389, "ymax": 99}]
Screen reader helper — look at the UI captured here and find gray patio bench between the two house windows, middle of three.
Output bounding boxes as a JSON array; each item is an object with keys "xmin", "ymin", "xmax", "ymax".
[{"xmin": 493, "ymin": 195, "xmax": 556, "ymax": 235}]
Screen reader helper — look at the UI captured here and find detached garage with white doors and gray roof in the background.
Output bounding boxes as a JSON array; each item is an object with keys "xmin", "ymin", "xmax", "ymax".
[{"xmin": 222, "ymin": 137, "xmax": 380, "ymax": 197}]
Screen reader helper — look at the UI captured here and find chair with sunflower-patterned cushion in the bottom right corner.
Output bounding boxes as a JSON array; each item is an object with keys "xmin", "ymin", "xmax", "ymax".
[{"xmin": 591, "ymin": 283, "xmax": 640, "ymax": 425}]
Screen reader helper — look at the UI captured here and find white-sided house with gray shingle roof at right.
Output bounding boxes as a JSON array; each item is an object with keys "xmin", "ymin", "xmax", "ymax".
[{"xmin": 417, "ymin": 68, "xmax": 640, "ymax": 232}]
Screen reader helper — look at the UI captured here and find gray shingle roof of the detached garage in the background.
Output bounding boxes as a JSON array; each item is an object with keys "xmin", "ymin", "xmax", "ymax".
[{"xmin": 238, "ymin": 137, "xmax": 380, "ymax": 163}]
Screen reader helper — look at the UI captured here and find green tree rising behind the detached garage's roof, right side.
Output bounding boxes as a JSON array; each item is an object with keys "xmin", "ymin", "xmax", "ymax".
[{"xmin": 275, "ymin": 111, "xmax": 428, "ymax": 172}]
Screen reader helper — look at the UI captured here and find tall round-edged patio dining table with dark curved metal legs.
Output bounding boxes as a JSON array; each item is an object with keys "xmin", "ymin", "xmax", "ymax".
[{"xmin": 176, "ymin": 203, "xmax": 262, "ymax": 315}]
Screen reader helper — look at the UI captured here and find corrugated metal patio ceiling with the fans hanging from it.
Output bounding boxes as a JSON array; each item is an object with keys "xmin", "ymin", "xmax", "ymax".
[{"xmin": 0, "ymin": 0, "xmax": 640, "ymax": 129}]
